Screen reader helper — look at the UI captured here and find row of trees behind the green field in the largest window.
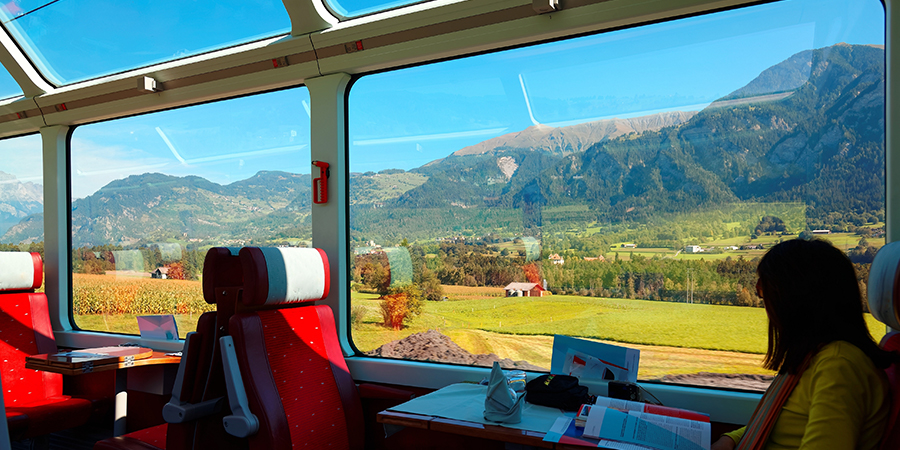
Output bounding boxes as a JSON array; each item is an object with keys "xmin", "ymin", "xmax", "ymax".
[{"xmin": 352, "ymin": 237, "xmax": 876, "ymax": 326}]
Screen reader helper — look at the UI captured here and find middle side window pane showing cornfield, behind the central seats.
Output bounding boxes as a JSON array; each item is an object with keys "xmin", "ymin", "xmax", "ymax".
[{"xmin": 71, "ymin": 87, "xmax": 311, "ymax": 337}]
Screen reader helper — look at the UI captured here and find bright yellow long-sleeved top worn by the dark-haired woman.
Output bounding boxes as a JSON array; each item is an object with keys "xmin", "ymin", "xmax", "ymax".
[{"xmin": 725, "ymin": 341, "xmax": 890, "ymax": 450}]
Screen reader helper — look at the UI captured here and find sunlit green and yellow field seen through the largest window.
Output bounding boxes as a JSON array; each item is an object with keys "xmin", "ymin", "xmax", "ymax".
[{"xmin": 351, "ymin": 293, "xmax": 885, "ymax": 379}]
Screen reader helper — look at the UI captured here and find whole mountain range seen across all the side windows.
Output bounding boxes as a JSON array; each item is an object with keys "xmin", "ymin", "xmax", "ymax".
[{"xmin": 0, "ymin": 44, "xmax": 885, "ymax": 246}]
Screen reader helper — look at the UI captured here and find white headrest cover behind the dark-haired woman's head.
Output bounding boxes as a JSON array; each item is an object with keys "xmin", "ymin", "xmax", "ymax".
[{"xmin": 867, "ymin": 241, "xmax": 900, "ymax": 330}]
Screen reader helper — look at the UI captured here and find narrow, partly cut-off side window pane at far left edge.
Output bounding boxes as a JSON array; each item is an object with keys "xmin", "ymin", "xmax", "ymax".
[{"xmin": 0, "ymin": 134, "xmax": 44, "ymax": 257}]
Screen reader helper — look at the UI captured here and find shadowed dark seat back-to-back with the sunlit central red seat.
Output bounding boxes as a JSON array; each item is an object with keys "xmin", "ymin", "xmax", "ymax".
[{"xmin": 94, "ymin": 247, "xmax": 247, "ymax": 450}]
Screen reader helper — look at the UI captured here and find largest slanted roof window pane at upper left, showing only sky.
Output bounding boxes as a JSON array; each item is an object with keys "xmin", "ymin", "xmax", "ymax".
[{"xmin": 0, "ymin": 0, "xmax": 290, "ymax": 84}]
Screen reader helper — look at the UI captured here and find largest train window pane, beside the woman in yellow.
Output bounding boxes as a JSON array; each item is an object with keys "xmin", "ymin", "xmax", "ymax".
[{"xmin": 348, "ymin": 0, "xmax": 885, "ymax": 389}]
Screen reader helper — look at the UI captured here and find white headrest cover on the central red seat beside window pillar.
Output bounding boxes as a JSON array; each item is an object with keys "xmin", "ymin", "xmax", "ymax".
[{"xmin": 260, "ymin": 247, "xmax": 328, "ymax": 305}]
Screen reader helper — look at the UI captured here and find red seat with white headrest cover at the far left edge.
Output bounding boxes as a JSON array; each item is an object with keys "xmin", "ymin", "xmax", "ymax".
[{"xmin": 0, "ymin": 252, "xmax": 112, "ymax": 440}]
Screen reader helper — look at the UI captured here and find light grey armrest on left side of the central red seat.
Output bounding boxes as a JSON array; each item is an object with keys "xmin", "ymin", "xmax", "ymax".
[{"xmin": 219, "ymin": 336, "xmax": 259, "ymax": 438}]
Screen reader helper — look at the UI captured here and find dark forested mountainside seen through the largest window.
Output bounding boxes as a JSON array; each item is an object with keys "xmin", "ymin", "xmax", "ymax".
[{"xmin": 382, "ymin": 44, "xmax": 884, "ymax": 229}]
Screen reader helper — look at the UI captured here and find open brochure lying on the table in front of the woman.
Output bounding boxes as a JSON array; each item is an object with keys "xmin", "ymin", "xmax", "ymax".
[{"xmin": 583, "ymin": 405, "xmax": 711, "ymax": 450}]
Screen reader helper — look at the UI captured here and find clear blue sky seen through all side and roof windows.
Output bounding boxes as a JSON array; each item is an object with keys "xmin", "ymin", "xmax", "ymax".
[{"xmin": 0, "ymin": 0, "xmax": 884, "ymax": 198}]
